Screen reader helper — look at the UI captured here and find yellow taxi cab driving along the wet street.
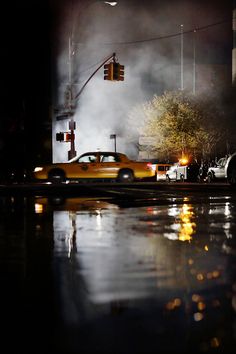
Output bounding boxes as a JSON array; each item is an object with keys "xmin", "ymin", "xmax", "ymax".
[{"xmin": 33, "ymin": 151, "xmax": 155, "ymax": 183}]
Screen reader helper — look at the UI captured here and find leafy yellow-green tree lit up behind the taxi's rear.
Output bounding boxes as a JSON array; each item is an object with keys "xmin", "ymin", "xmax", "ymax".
[{"xmin": 129, "ymin": 91, "xmax": 222, "ymax": 159}]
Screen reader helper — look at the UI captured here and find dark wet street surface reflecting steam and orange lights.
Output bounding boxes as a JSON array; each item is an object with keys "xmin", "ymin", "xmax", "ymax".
[{"xmin": 0, "ymin": 184, "xmax": 236, "ymax": 354}]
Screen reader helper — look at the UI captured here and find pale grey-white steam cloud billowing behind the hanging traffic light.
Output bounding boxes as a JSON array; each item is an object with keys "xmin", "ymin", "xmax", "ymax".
[{"xmin": 53, "ymin": 0, "xmax": 231, "ymax": 162}]
